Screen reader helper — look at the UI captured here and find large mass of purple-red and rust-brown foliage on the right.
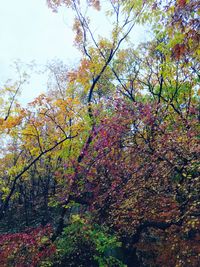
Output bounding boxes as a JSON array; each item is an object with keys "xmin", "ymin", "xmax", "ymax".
[{"xmin": 86, "ymin": 99, "xmax": 200, "ymax": 266}]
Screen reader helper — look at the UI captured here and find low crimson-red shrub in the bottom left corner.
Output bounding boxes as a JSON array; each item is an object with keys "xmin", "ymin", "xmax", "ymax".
[{"xmin": 0, "ymin": 226, "xmax": 56, "ymax": 267}]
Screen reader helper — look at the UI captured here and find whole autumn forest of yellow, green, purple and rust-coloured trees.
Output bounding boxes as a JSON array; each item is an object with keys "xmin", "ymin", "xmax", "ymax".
[{"xmin": 0, "ymin": 0, "xmax": 200, "ymax": 267}]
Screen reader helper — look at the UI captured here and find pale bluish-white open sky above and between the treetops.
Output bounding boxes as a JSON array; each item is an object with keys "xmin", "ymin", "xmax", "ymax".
[{"xmin": 0, "ymin": 0, "xmax": 150, "ymax": 103}]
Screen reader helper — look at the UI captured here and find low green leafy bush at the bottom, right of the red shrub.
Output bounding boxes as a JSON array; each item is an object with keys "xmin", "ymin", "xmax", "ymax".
[{"xmin": 56, "ymin": 215, "xmax": 125, "ymax": 266}]
